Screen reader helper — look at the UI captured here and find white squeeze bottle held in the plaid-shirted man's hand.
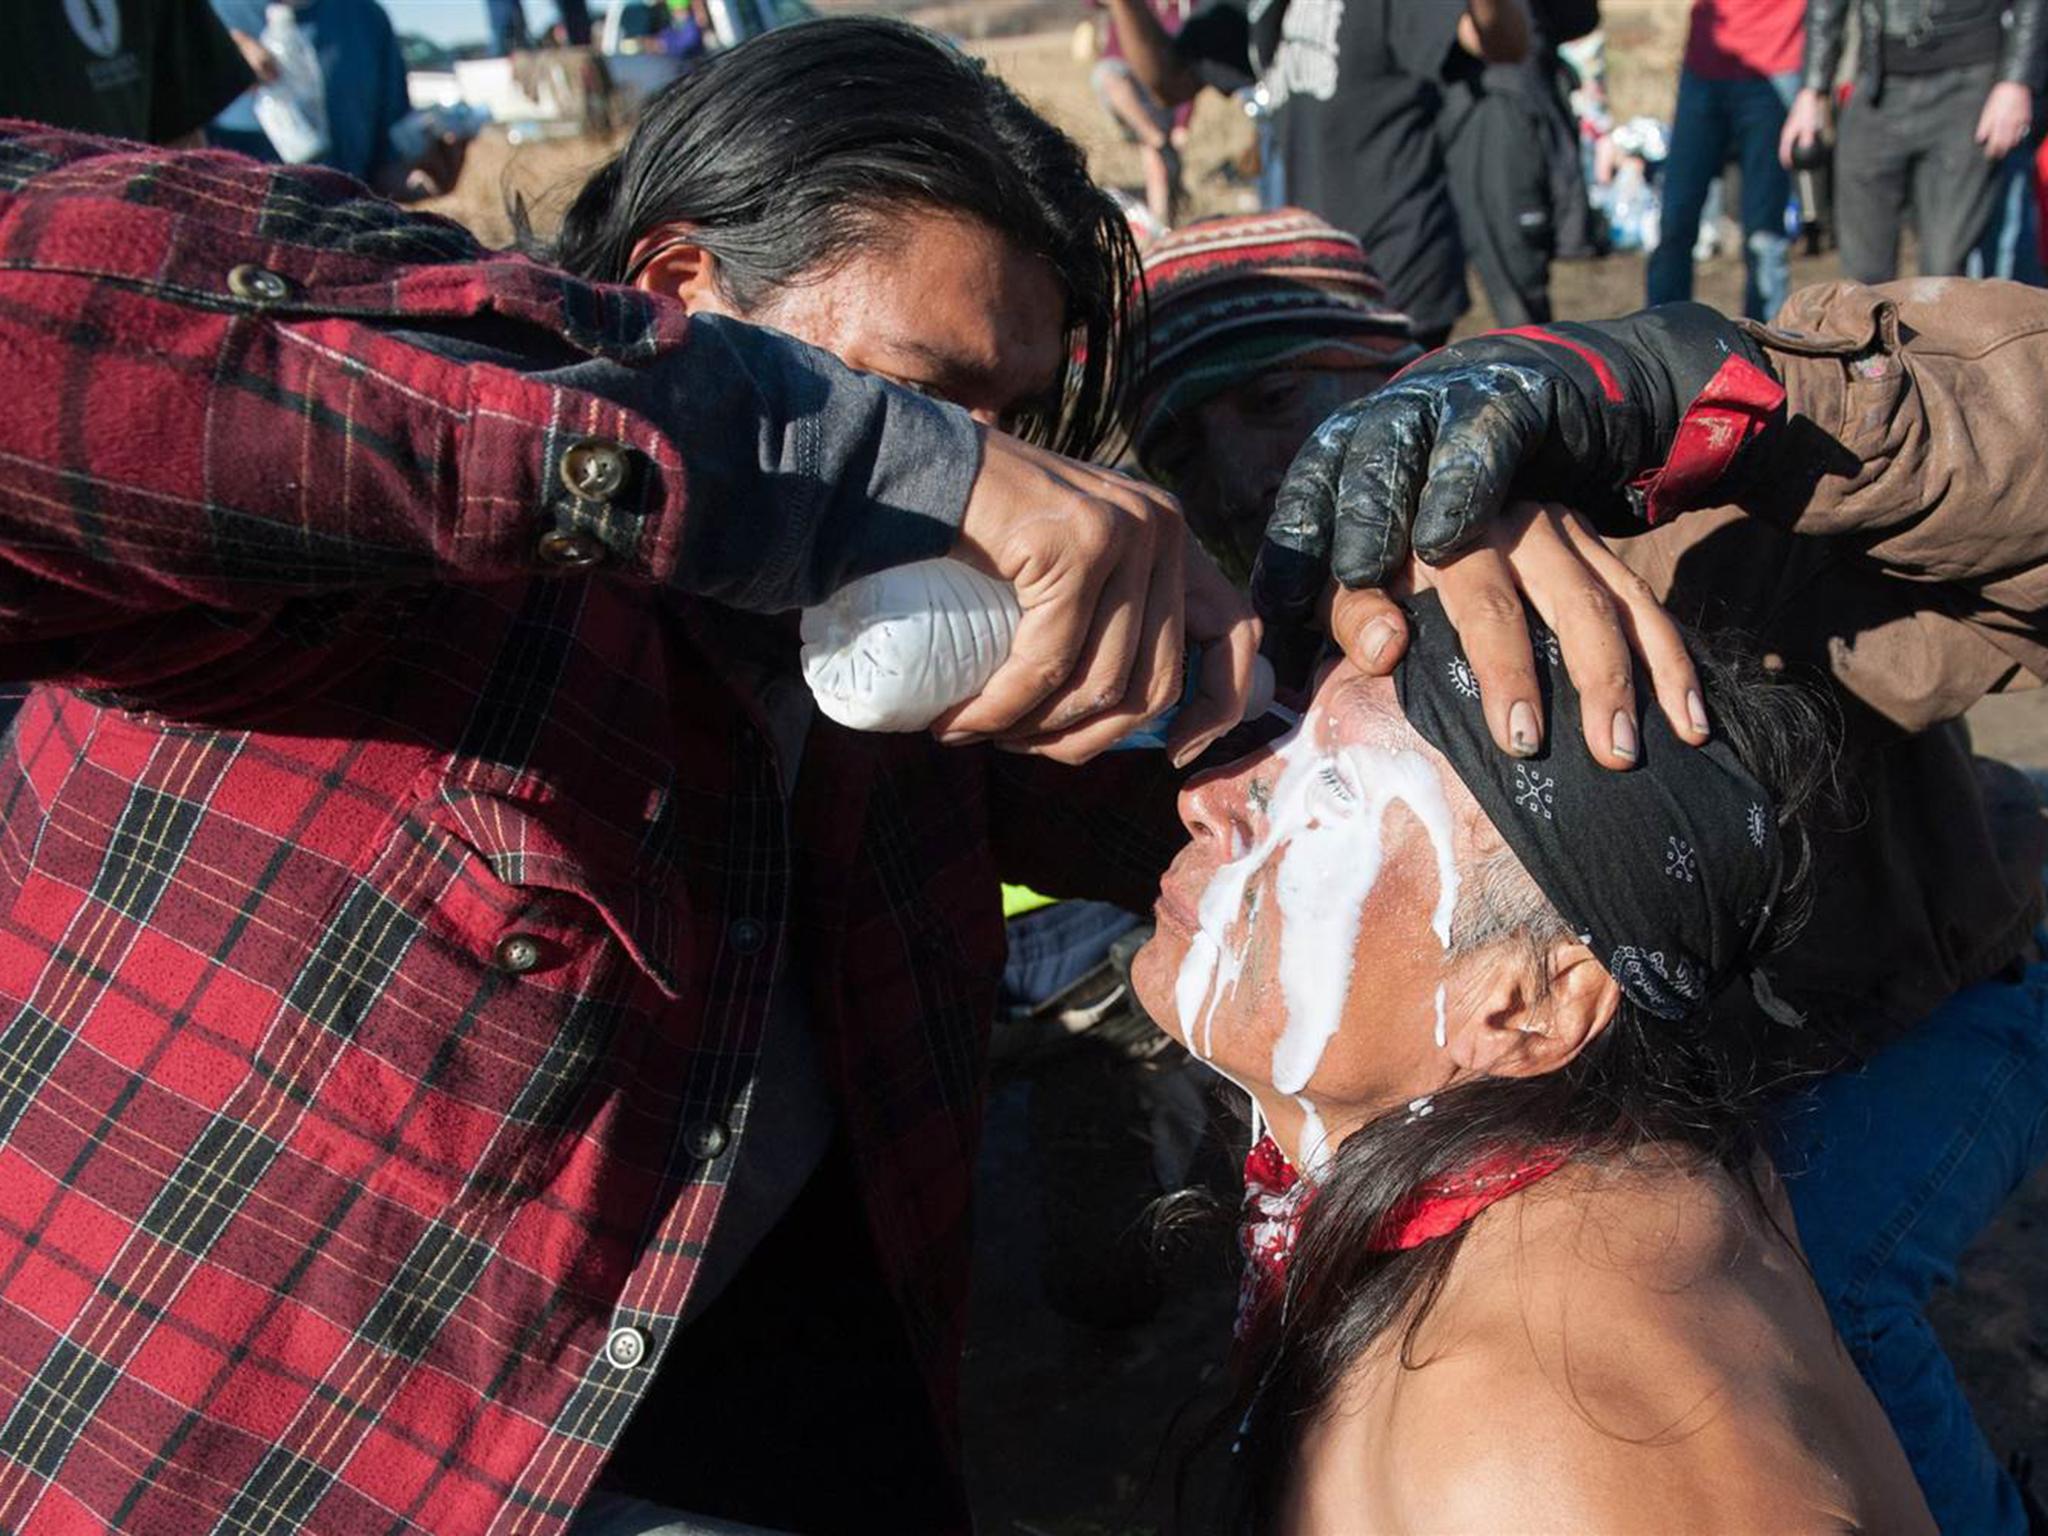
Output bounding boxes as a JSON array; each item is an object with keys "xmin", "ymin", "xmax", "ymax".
[{"xmin": 801, "ymin": 559, "xmax": 1274, "ymax": 748}]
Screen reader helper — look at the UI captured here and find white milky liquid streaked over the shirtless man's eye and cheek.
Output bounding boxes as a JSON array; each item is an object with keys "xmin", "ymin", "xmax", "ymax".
[{"xmin": 1174, "ymin": 725, "xmax": 1458, "ymax": 1094}]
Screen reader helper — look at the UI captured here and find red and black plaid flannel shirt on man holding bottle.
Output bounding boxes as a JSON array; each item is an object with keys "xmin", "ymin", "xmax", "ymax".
[{"xmin": 0, "ymin": 127, "xmax": 1171, "ymax": 1536}]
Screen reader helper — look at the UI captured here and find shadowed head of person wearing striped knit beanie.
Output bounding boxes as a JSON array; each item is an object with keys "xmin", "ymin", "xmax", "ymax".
[{"xmin": 1130, "ymin": 209, "xmax": 1421, "ymax": 582}]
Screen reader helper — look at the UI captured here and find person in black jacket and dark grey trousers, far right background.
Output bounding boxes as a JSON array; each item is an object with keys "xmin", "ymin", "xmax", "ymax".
[{"xmin": 1780, "ymin": 0, "xmax": 2048, "ymax": 283}]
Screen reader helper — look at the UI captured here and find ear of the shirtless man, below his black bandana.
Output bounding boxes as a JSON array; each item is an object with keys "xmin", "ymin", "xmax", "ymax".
[{"xmin": 1446, "ymin": 944, "xmax": 1622, "ymax": 1077}]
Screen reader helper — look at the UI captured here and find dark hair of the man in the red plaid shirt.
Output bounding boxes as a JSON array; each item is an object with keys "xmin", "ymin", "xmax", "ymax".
[{"xmin": 514, "ymin": 16, "xmax": 1141, "ymax": 459}]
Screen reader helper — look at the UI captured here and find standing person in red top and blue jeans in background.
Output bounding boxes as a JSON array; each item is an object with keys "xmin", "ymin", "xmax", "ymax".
[{"xmin": 1649, "ymin": 0, "xmax": 1804, "ymax": 319}]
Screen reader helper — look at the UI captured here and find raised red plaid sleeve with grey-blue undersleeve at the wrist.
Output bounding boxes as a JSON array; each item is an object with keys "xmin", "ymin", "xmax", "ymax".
[{"xmin": 0, "ymin": 123, "xmax": 979, "ymax": 684}]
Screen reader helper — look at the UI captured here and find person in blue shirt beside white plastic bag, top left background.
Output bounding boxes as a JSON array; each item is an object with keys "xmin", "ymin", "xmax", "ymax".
[{"xmin": 211, "ymin": 0, "xmax": 467, "ymax": 203}]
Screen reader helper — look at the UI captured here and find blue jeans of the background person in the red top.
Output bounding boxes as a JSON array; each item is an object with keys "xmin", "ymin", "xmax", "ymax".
[{"xmin": 1649, "ymin": 70, "xmax": 1798, "ymax": 319}]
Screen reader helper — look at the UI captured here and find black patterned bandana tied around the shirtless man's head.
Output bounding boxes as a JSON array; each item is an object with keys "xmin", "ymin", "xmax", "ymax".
[{"xmin": 1395, "ymin": 592, "xmax": 1784, "ymax": 1018}]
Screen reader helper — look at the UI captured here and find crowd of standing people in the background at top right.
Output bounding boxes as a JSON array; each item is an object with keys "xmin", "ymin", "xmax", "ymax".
[{"xmin": 1104, "ymin": 0, "xmax": 2048, "ymax": 319}]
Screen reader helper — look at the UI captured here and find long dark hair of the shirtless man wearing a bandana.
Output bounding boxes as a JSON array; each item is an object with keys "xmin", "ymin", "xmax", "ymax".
[{"xmin": 1210, "ymin": 635, "xmax": 1835, "ymax": 1532}]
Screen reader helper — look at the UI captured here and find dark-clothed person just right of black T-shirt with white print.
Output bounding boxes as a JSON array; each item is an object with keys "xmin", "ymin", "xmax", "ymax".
[{"xmin": 1438, "ymin": 0, "xmax": 1599, "ymax": 326}]
